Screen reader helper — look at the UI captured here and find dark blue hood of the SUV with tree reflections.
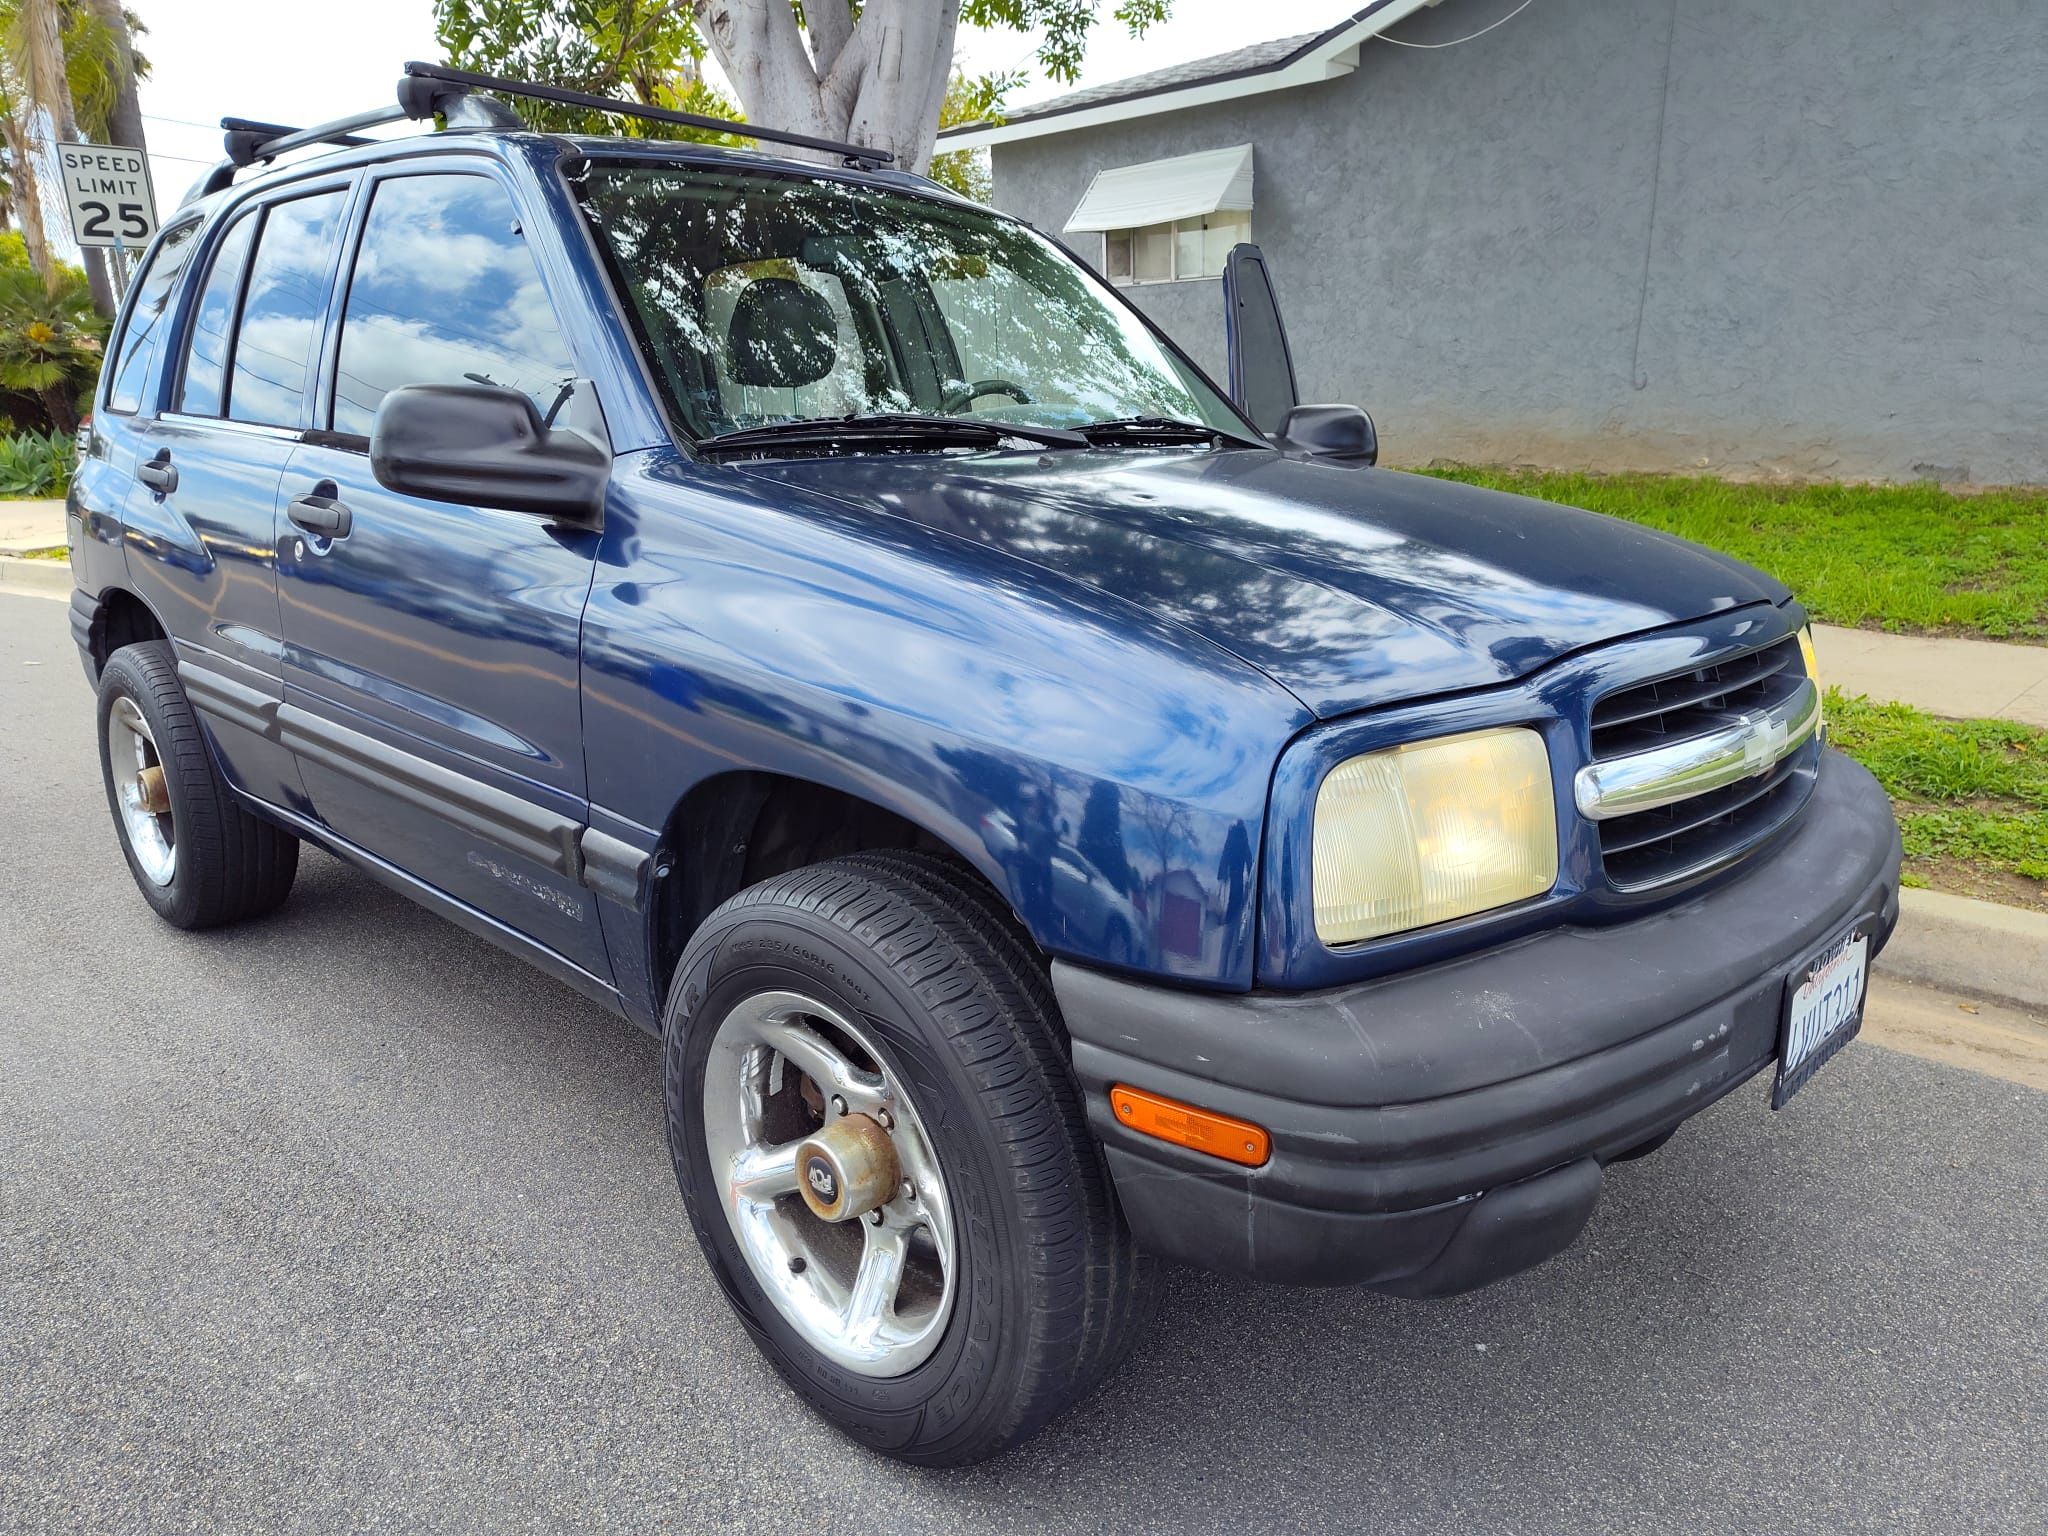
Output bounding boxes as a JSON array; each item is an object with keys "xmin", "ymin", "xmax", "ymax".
[{"xmin": 741, "ymin": 451, "xmax": 1790, "ymax": 719}]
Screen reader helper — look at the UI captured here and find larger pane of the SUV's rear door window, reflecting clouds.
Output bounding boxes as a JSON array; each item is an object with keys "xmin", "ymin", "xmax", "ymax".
[{"xmin": 227, "ymin": 190, "xmax": 342, "ymax": 426}]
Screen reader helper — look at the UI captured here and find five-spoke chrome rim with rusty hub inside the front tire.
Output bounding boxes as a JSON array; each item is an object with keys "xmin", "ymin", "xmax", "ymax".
[{"xmin": 700, "ymin": 991, "xmax": 958, "ymax": 1376}]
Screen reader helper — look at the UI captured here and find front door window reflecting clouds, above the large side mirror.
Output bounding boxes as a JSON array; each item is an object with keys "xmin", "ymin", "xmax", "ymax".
[{"xmin": 334, "ymin": 176, "xmax": 575, "ymax": 436}]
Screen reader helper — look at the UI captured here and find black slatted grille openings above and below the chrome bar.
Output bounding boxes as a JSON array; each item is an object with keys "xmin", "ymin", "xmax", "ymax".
[{"xmin": 1589, "ymin": 637, "xmax": 1819, "ymax": 891}]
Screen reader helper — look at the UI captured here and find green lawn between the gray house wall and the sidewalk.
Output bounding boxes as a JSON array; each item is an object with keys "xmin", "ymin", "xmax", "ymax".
[{"xmin": 1423, "ymin": 467, "xmax": 2048, "ymax": 645}]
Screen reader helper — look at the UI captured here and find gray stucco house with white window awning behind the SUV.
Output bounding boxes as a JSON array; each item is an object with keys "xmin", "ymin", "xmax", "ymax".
[{"xmin": 944, "ymin": 0, "xmax": 2048, "ymax": 483}]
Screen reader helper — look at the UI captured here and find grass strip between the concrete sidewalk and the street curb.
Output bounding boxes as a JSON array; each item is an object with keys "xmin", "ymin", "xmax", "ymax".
[{"xmin": 1827, "ymin": 688, "xmax": 2048, "ymax": 911}]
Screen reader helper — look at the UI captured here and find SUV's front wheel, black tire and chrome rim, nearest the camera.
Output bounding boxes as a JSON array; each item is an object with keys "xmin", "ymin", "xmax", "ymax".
[{"xmin": 664, "ymin": 854, "xmax": 1149, "ymax": 1466}]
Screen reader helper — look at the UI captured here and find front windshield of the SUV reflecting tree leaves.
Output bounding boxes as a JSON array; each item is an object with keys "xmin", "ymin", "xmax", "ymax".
[{"xmin": 578, "ymin": 160, "xmax": 1253, "ymax": 448}]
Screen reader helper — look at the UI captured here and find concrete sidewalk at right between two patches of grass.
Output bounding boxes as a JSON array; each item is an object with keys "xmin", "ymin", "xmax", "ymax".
[{"xmin": 1812, "ymin": 625, "xmax": 2048, "ymax": 727}]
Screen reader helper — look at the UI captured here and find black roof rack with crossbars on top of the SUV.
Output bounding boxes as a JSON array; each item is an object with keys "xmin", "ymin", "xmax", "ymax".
[{"xmin": 184, "ymin": 59, "xmax": 895, "ymax": 203}]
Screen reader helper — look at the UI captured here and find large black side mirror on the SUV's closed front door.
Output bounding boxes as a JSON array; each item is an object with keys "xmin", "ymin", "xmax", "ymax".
[{"xmin": 371, "ymin": 385, "xmax": 612, "ymax": 522}]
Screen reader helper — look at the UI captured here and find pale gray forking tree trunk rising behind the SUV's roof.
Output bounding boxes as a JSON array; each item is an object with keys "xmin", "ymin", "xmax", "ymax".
[{"xmin": 694, "ymin": 0, "xmax": 961, "ymax": 174}]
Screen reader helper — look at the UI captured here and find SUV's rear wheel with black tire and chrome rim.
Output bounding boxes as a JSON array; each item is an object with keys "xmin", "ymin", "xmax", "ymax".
[{"xmin": 98, "ymin": 641, "xmax": 299, "ymax": 928}]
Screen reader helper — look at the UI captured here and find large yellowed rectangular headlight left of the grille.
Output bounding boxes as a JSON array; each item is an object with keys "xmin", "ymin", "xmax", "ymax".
[{"xmin": 1311, "ymin": 727, "xmax": 1556, "ymax": 944}]
